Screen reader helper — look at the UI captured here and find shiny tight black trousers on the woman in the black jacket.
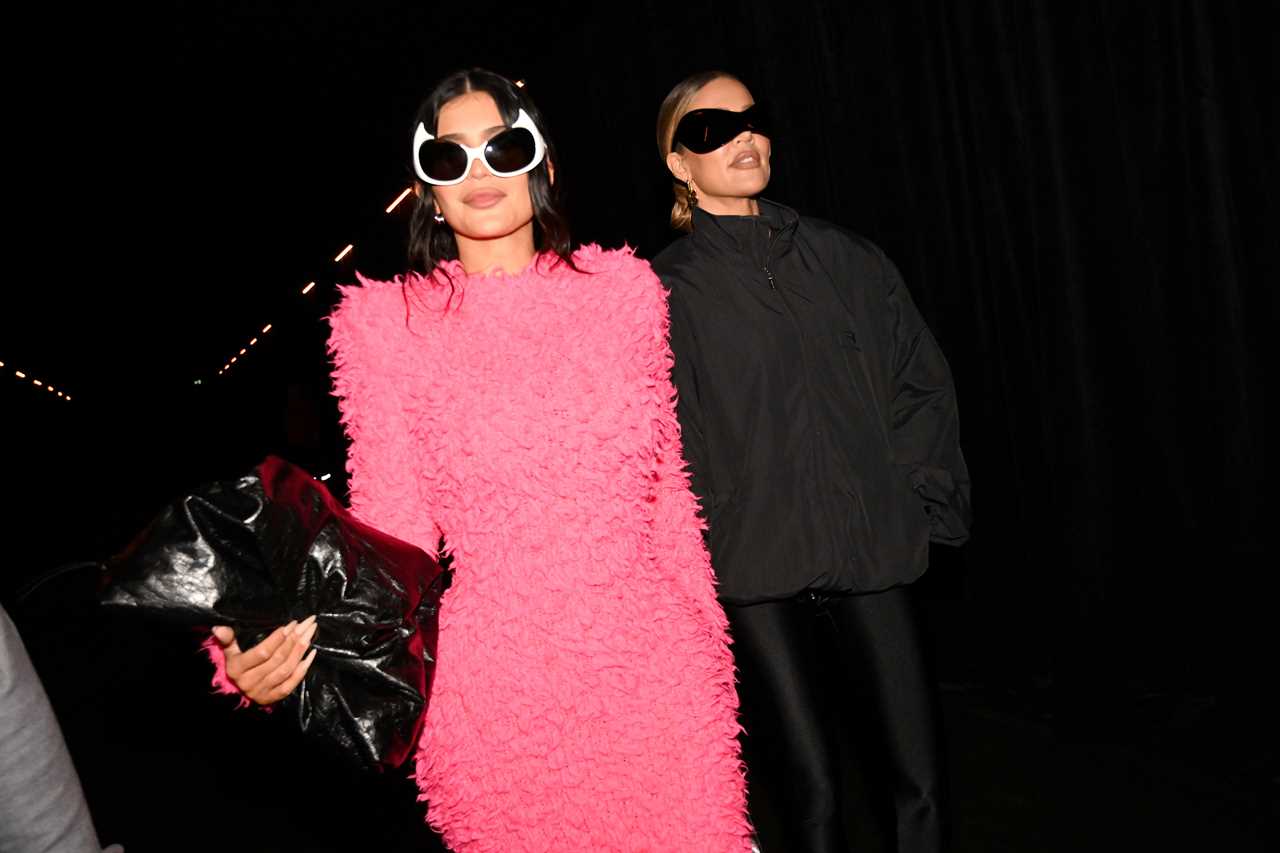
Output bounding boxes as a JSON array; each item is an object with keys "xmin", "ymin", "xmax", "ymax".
[{"xmin": 724, "ymin": 588, "xmax": 947, "ymax": 853}]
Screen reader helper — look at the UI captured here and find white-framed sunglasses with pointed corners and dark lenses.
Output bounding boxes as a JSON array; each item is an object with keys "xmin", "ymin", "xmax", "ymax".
[{"xmin": 413, "ymin": 110, "xmax": 547, "ymax": 187}]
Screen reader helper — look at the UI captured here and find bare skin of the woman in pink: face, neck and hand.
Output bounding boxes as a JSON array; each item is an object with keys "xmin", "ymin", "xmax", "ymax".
[{"xmin": 214, "ymin": 86, "xmax": 556, "ymax": 704}]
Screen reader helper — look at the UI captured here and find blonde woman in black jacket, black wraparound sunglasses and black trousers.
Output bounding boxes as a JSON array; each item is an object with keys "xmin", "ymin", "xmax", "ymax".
[{"xmin": 653, "ymin": 72, "xmax": 969, "ymax": 852}]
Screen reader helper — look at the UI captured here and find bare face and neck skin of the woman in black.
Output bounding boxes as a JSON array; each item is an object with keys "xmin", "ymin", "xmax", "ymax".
[{"xmin": 667, "ymin": 77, "xmax": 773, "ymax": 216}]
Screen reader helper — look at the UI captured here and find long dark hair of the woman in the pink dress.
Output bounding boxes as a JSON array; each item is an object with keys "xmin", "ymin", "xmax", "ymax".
[{"xmin": 406, "ymin": 68, "xmax": 573, "ymax": 274}]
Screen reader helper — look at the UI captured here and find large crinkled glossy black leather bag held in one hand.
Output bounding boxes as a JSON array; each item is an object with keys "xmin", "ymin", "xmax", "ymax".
[{"xmin": 102, "ymin": 457, "xmax": 445, "ymax": 767}]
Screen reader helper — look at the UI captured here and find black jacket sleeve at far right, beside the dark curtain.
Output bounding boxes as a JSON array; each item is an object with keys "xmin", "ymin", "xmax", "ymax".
[{"xmin": 877, "ymin": 250, "xmax": 972, "ymax": 544}]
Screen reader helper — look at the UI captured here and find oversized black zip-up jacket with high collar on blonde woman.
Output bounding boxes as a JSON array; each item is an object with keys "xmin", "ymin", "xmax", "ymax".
[{"xmin": 653, "ymin": 201, "xmax": 969, "ymax": 603}]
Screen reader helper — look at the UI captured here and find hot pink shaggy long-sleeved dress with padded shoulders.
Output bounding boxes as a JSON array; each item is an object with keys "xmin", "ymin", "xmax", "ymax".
[{"xmin": 320, "ymin": 246, "xmax": 750, "ymax": 853}]
